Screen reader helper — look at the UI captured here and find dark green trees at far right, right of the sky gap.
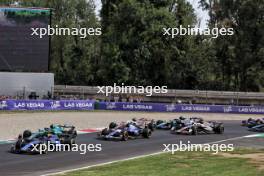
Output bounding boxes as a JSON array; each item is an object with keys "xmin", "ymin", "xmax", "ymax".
[{"xmin": 200, "ymin": 0, "xmax": 264, "ymax": 91}]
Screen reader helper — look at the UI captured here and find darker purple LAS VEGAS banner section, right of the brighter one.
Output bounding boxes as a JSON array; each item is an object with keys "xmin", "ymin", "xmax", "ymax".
[{"xmin": 97, "ymin": 102, "xmax": 264, "ymax": 114}]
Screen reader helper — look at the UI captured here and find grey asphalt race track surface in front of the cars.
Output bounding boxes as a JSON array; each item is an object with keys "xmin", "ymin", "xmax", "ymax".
[{"xmin": 0, "ymin": 121, "xmax": 264, "ymax": 176}]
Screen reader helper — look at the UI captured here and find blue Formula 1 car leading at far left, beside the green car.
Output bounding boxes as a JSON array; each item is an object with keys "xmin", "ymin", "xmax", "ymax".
[{"xmin": 11, "ymin": 130, "xmax": 61, "ymax": 154}]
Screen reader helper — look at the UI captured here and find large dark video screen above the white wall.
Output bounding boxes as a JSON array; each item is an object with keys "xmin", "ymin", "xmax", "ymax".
[{"xmin": 0, "ymin": 7, "xmax": 51, "ymax": 72}]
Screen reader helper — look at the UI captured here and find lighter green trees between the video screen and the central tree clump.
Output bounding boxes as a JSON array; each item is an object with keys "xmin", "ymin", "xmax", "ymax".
[{"xmin": 14, "ymin": 0, "xmax": 100, "ymax": 85}]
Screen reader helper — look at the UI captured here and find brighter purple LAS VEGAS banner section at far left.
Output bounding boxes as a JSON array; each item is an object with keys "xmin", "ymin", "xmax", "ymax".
[{"xmin": 0, "ymin": 100, "xmax": 94, "ymax": 110}]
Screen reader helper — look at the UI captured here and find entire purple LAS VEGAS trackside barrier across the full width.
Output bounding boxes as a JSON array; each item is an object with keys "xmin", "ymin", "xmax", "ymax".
[{"xmin": 0, "ymin": 100, "xmax": 264, "ymax": 114}]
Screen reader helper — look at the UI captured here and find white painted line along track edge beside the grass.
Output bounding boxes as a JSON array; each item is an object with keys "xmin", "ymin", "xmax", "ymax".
[{"xmin": 41, "ymin": 135, "xmax": 256, "ymax": 176}]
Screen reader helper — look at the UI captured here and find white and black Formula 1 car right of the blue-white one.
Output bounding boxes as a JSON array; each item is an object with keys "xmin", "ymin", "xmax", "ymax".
[{"xmin": 171, "ymin": 122, "xmax": 224, "ymax": 135}]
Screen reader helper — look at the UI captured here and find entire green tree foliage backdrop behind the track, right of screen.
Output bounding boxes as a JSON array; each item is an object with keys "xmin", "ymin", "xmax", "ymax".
[{"xmin": 2, "ymin": 0, "xmax": 264, "ymax": 91}]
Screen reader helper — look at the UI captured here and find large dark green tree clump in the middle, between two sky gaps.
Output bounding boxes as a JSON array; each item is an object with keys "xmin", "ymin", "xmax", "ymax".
[{"xmin": 99, "ymin": 0, "xmax": 210, "ymax": 88}]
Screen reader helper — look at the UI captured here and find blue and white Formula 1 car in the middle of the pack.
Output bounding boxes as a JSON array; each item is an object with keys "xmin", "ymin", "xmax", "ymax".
[{"xmin": 98, "ymin": 122, "xmax": 152, "ymax": 141}]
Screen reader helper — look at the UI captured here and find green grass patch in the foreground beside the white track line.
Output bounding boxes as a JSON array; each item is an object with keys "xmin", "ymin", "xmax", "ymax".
[{"xmin": 58, "ymin": 150, "xmax": 264, "ymax": 176}]
